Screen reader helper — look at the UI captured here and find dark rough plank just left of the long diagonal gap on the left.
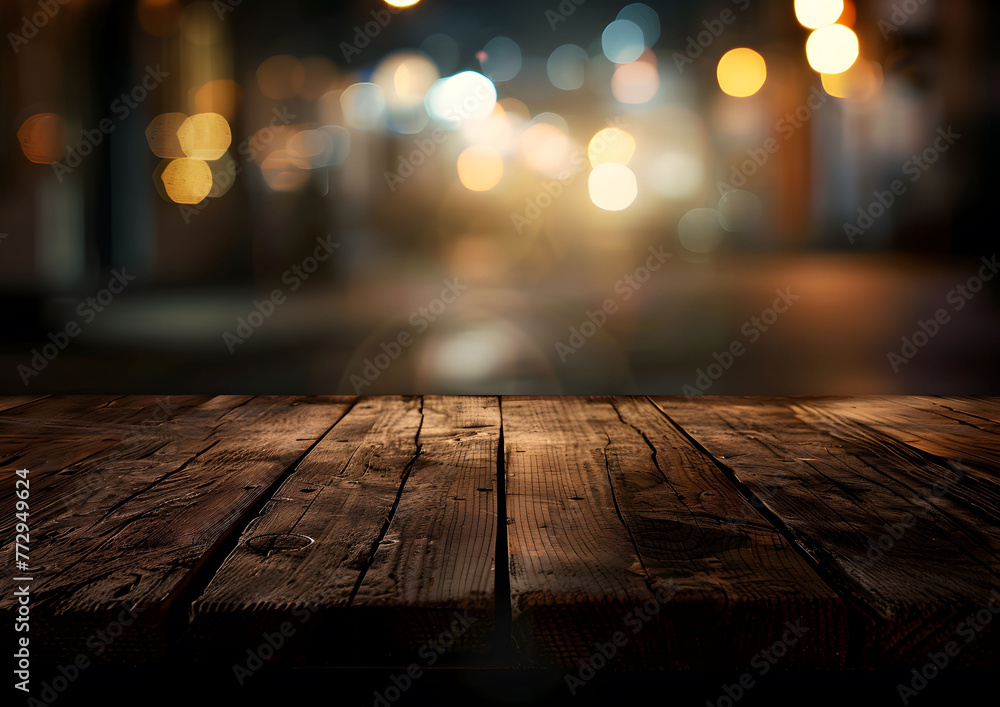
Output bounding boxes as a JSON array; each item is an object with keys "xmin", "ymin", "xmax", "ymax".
[{"xmin": 0, "ymin": 397, "xmax": 351, "ymax": 662}]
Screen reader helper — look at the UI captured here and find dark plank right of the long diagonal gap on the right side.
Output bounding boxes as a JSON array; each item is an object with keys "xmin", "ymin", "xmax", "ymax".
[{"xmin": 655, "ymin": 398, "xmax": 1000, "ymax": 667}]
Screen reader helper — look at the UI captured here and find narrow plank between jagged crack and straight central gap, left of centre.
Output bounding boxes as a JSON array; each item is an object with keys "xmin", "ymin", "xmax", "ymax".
[{"xmin": 351, "ymin": 396, "xmax": 500, "ymax": 653}]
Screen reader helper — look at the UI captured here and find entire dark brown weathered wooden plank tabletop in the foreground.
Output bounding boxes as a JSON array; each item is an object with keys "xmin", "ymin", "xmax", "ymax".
[{"xmin": 0, "ymin": 396, "xmax": 1000, "ymax": 672}]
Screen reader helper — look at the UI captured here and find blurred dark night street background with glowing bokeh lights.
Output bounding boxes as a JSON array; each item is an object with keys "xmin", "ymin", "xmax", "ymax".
[{"xmin": 0, "ymin": 0, "xmax": 1000, "ymax": 394}]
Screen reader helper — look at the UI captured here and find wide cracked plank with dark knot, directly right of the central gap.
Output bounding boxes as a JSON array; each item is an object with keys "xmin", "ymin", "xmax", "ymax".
[{"xmin": 503, "ymin": 398, "xmax": 847, "ymax": 669}]
